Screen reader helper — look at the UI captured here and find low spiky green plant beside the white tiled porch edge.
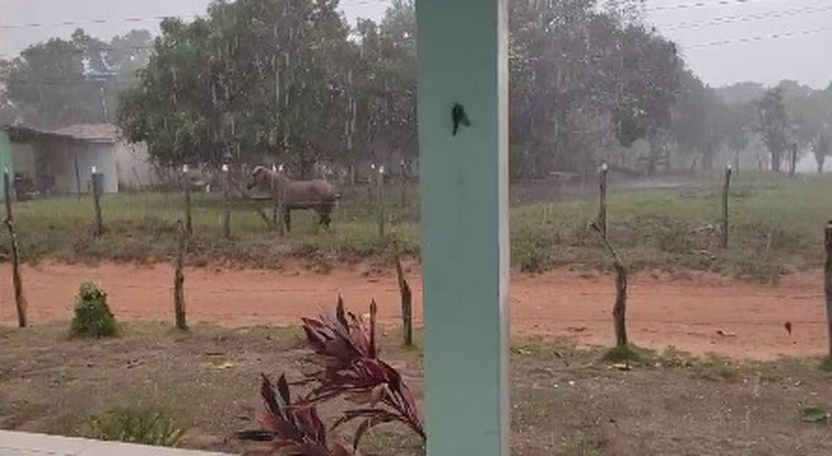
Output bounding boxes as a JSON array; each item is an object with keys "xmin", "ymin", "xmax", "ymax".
[{"xmin": 90, "ymin": 409, "xmax": 185, "ymax": 447}]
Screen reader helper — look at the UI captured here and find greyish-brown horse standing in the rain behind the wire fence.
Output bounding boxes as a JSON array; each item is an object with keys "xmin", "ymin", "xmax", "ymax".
[{"xmin": 246, "ymin": 166, "xmax": 341, "ymax": 231}]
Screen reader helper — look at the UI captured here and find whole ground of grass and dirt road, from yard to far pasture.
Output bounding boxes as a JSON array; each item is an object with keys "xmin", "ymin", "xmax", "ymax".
[{"xmin": 0, "ymin": 173, "xmax": 832, "ymax": 456}]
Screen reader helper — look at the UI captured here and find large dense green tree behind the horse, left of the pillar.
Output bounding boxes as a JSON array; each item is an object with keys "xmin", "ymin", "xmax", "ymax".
[{"xmin": 119, "ymin": 0, "xmax": 350, "ymax": 171}]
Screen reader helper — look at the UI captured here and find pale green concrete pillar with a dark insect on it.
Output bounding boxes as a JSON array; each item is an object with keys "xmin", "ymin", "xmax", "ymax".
[{"xmin": 416, "ymin": 0, "xmax": 509, "ymax": 456}]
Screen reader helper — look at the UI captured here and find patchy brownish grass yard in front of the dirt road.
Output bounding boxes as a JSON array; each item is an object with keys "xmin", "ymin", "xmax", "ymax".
[{"xmin": 0, "ymin": 324, "xmax": 832, "ymax": 456}]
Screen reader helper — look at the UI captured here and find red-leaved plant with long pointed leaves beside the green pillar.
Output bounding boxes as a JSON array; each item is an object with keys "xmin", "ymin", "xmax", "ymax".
[{"xmin": 237, "ymin": 296, "xmax": 425, "ymax": 456}]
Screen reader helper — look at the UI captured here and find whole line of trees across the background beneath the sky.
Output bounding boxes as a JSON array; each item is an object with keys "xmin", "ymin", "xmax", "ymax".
[{"xmin": 0, "ymin": 0, "xmax": 832, "ymax": 178}]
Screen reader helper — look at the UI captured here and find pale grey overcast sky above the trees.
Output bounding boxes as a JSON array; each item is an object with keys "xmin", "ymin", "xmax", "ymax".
[{"xmin": 0, "ymin": 0, "xmax": 832, "ymax": 88}]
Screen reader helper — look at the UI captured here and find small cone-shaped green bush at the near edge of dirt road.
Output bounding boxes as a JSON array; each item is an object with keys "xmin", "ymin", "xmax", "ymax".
[{"xmin": 70, "ymin": 282, "xmax": 118, "ymax": 338}]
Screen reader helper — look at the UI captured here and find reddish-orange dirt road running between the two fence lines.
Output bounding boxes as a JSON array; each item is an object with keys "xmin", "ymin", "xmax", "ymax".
[{"xmin": 0, "ymin": 263, "xmax": 827, "ymax": 359}]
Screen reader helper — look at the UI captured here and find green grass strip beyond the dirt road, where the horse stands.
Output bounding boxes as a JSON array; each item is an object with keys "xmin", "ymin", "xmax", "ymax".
[{"xmin": 0, "ymin": 174, "xmax": 832, "ymax": 281}]
